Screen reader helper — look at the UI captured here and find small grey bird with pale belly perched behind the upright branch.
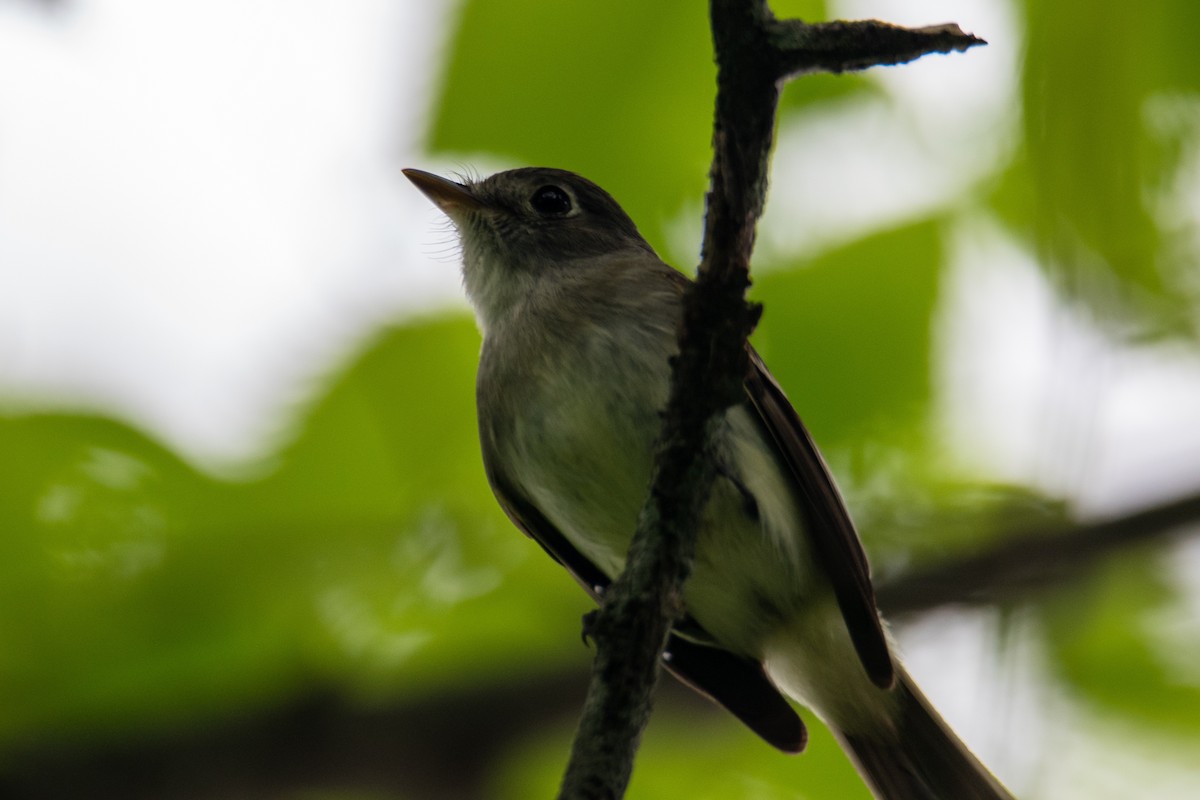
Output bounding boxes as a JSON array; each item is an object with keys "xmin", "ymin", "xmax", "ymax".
[{"xmin": 404, "ymin": 168, "xmax": 1010, "ymax": 800}]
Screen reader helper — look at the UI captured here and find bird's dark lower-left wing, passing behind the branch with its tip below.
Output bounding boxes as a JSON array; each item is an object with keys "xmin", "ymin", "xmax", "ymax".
[{"xmin": 485, "ymin": 458, "xmax": 808, "ymax": 753}]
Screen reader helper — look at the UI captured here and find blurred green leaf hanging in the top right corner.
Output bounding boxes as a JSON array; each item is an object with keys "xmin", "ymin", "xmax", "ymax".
[{"xmin": 1021, "ymin": 0, "xmax": 1200, "ymax": 333}]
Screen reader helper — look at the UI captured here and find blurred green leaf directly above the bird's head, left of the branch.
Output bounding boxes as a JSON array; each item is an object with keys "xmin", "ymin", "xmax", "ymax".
[{"xmin": 430, "ymin": 0, "xmax": 715, "ymax": 251}]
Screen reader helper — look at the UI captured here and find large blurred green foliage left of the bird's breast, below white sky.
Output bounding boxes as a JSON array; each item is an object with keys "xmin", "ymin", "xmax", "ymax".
[{"xmin": 0, "ymin": 317, "xmax": 592, "ymax": 742}]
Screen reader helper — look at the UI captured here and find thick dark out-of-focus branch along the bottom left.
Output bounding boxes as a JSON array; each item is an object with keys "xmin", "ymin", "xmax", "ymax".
[{"xmin": 0, "ymin": 668, "xmax": 587, "ymax": 800}]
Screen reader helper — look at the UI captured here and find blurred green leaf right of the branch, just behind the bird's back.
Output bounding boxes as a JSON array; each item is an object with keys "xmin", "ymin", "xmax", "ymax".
[{"xmin": 752, "ymin": 222, "xmax": 942, "ymax": 447}]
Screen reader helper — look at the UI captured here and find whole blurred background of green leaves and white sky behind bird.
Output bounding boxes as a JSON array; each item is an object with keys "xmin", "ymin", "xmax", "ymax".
[{"xmin": 0, "ymin": 0, "xmax": 1200, "ymax": 800}]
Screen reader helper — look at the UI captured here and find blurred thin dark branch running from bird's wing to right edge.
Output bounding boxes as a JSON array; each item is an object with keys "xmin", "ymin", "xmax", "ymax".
[{"xmin": 876, "ymin": 494, "xmax": 1200, "ymax": 618}]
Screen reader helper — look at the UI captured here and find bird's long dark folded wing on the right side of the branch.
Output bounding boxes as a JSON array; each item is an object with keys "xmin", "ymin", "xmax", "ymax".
[{"xmin": 745, "ymin": 348, "xmax": 895, "ymax": 688}]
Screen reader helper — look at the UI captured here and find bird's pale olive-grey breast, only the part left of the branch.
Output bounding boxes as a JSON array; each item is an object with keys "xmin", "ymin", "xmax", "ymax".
[{"xmin": 480, "ymin": 309, "xmax": 673, "ymax": 576}]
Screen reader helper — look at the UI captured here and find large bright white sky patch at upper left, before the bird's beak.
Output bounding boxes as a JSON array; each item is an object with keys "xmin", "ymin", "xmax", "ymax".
[{"xmin": 0, "ymin": 0, "xmax": 461, "ymax": 461}]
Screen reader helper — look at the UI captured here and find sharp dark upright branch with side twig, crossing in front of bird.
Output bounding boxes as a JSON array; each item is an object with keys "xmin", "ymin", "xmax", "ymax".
[{"xmin": 559, "ymin": 0, "xmax": 979, "ymax": 800}]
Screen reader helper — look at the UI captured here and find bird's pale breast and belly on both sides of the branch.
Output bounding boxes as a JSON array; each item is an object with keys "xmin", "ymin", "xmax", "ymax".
[{"xmin": 480, "ymin": 297, "xmax": 814, "ymax": 656}]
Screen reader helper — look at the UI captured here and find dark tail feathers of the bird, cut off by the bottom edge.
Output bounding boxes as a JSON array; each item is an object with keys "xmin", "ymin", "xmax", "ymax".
[{"xmin": 838, "ymin": 670, "xmax": 1013, "ymax": 800}]
